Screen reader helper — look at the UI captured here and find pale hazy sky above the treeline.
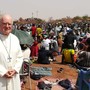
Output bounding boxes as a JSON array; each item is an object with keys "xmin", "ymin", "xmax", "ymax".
[{"xmin": 0, "ymin": 0, "xmax": 90, "ymax": 20}]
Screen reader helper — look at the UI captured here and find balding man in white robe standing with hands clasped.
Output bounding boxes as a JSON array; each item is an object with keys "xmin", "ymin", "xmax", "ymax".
[{"xmin": 0, "ymin": 14, "xmax": 23, "ymax": 90}]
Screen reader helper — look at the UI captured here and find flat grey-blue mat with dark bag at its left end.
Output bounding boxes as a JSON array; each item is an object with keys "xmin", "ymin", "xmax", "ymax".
[{"xmin": 30, "ymin": 67, "xmax": 52, "ymax": 80}]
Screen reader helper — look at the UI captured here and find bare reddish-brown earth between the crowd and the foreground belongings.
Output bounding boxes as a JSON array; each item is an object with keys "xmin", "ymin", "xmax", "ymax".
[{"xmin": 22, "ymin": 56, "xmax": 78, "ymax": 90}]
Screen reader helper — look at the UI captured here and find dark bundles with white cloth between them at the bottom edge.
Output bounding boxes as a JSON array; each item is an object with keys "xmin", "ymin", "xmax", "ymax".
[{"xmin": 37, "ymin": 79, "xmax": 74, "ymax": 90}]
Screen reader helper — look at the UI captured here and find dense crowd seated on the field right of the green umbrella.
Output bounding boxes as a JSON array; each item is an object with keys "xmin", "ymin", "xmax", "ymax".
[{"xmin": 17, "ymin": 22, "xmax": 90, "ymax": 90}]
